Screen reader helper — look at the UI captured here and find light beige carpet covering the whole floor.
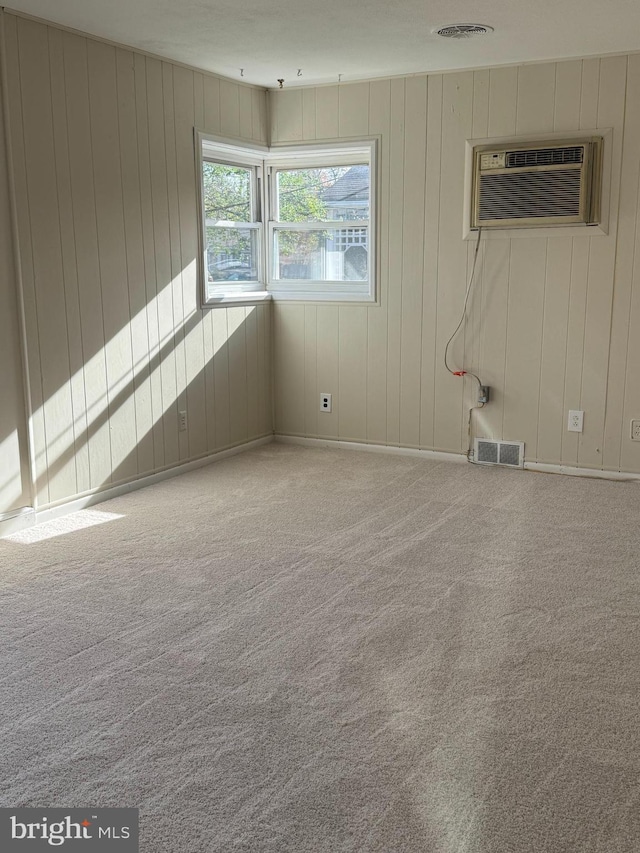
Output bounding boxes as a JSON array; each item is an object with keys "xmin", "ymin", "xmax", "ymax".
[{"xmin": 0, "ymin": 444, "xmax": 640, "ymax": 853}]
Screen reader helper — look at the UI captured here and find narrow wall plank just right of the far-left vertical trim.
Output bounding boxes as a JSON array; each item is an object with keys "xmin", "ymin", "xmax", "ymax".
[{"xmin": 3, "ymin": 13, "xmax": 49, "ymax": 504}]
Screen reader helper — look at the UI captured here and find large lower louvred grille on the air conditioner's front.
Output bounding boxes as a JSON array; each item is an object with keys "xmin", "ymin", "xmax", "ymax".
[{"xmin": 478, "ymin": 169, "xmax": 581, "ymax": 224}]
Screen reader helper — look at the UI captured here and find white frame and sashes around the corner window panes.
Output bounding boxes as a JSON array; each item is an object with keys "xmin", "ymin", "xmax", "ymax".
[{"xmin": 194, "ymin": 130, "xmax": 377, "ymax": 307}]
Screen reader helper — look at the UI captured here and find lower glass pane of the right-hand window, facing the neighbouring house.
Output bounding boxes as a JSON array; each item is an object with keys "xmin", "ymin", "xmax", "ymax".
[{"xmin": 274, "ymin": 228, "xmax": 369, "ymax": 281}]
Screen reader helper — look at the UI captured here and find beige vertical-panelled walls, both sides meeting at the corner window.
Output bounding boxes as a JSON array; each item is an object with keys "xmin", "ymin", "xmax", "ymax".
[{"xmin": 0, "ymin": 6, "xmax": 640, "ymax": 512}]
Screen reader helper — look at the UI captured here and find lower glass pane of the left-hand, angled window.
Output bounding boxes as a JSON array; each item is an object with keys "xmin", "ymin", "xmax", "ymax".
[{"xmin": 206, "ymin": 226, "xmax": 258, "ymax": 284}]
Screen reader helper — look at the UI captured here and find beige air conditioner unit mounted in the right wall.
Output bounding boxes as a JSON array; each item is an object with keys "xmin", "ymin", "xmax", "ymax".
[{"xmin": 471, "ymin": 136, "xmax": 602, "ymax": 229}]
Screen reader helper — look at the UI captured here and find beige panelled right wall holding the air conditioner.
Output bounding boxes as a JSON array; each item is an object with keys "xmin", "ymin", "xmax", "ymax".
[{"xmin": 271, "ymin": 60, "xmax": 640, "ymax": 472}]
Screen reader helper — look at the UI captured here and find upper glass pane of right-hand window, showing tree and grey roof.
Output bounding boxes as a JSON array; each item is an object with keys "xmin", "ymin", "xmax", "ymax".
[{"xmin": 277, "ymin": 166, "xmax": 369, "ymax": 222}]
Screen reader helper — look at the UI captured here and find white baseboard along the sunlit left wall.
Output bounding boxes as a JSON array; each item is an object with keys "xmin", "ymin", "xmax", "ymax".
[{"xmin": 0, "ymin": 435, "xmax": 273, "ymax": 538}]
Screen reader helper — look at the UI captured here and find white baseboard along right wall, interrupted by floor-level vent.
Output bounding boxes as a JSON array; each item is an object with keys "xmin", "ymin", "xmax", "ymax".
[{"xmin": 274, "ymin": 433, "xmax": 640, "ymax": 481}]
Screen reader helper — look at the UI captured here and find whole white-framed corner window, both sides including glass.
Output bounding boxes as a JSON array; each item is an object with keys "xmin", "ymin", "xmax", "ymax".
[{"xmin": 196, "ymin": 134, "xmax": 375, "ymax": 304}]
